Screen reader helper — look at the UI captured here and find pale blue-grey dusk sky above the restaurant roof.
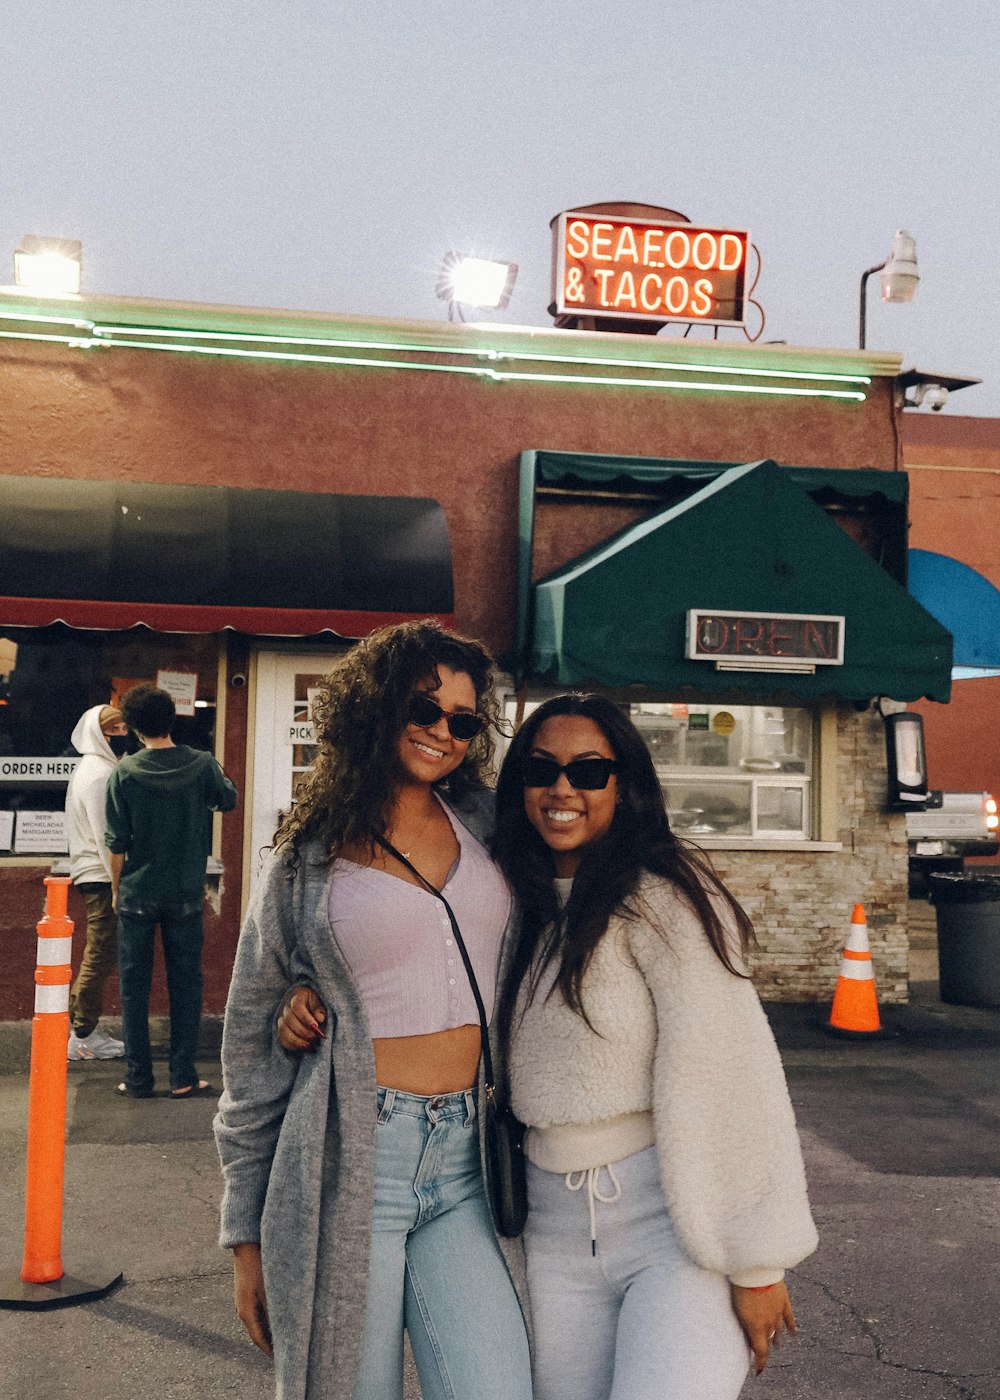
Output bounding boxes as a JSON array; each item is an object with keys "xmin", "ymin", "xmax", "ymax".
[{"xmin": 0, "ymin": 0, "xmax": 1000, "ymax": 417}]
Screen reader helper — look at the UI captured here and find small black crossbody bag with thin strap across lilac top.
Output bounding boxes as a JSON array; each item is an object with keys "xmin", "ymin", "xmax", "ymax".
[{"xmin": 378, "ymin": 837, "xmax": 528, "ymax": 1238}]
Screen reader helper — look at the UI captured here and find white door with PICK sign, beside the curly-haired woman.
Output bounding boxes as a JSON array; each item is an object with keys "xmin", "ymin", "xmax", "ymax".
[{"xmin": 248, "ymin": 651, "xmax": 342, "ymax": 885}]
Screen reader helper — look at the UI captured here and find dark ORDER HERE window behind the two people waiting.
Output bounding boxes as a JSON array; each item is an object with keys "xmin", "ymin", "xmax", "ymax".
[{"xmin": 0, "ymin": 624, "xmax": 218, "ymax": 861}]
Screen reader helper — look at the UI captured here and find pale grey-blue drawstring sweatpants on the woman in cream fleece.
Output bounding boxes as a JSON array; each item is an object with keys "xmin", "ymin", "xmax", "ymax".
[{"xmin": 524, "ymin": 1147, "xmax": 749, "ymax": 1400}]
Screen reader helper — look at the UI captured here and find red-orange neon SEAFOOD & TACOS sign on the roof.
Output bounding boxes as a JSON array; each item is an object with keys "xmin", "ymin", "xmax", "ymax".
[{"xmin": 553, "ymin": 210, "xmax": 751, "ymax": 326}]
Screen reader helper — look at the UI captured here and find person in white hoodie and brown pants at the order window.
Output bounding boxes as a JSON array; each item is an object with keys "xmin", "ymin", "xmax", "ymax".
[{"xmin": 66, "ymin": 704, "xmax": 129, "ymax": 1060}]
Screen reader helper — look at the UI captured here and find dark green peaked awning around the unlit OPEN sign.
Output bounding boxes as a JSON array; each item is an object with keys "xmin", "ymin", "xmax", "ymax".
[{"xmin": 524, "ymin": 462, "xmax": 951, "ymax": 701}]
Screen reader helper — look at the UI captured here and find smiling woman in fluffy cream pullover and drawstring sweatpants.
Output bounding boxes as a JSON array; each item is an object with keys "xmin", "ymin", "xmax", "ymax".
[{"xmin": 494, "ymin": 696, "xmax": 817, "ymax": 1400}]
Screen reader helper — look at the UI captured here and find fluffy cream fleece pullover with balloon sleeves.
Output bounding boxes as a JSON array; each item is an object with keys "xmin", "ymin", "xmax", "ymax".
[{"xmin": 508, "ymin": 876, "xmax": 817, "ymax": 1287}]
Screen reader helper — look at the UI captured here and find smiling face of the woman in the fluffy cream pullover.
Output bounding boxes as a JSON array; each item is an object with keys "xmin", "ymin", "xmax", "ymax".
[{"xmin": 524, "ymin": 714, "xmax": 618, "ymax": 879}]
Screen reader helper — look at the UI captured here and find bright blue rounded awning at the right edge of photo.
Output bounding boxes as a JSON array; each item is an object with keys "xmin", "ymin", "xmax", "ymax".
[{"xmin": 909, "ymin": 549, "xmax": 1000, "ymax": 680}]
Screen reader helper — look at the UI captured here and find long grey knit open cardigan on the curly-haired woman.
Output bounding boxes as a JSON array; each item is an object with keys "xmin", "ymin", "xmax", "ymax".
[{"xmin": 208, "ymin": 792, "xmax": 527, "ymax": 1400}]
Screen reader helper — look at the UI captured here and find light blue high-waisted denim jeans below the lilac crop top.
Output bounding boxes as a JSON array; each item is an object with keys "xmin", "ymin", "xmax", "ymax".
[{"xmin": 354, "ymin": 1088, "xmax": 531, "ymax": 1400}]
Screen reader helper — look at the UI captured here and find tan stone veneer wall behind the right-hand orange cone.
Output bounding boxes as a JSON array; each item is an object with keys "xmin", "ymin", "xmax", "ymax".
[{"xmin": 700, "ymin": 704, "xmax": 909, "ymax": 1002}]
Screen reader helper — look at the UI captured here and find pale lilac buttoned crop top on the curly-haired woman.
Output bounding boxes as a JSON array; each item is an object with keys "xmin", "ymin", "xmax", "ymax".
[{"xmin": 329, "ymin": 802, "xmax": 510, "ymax": 1039}]
